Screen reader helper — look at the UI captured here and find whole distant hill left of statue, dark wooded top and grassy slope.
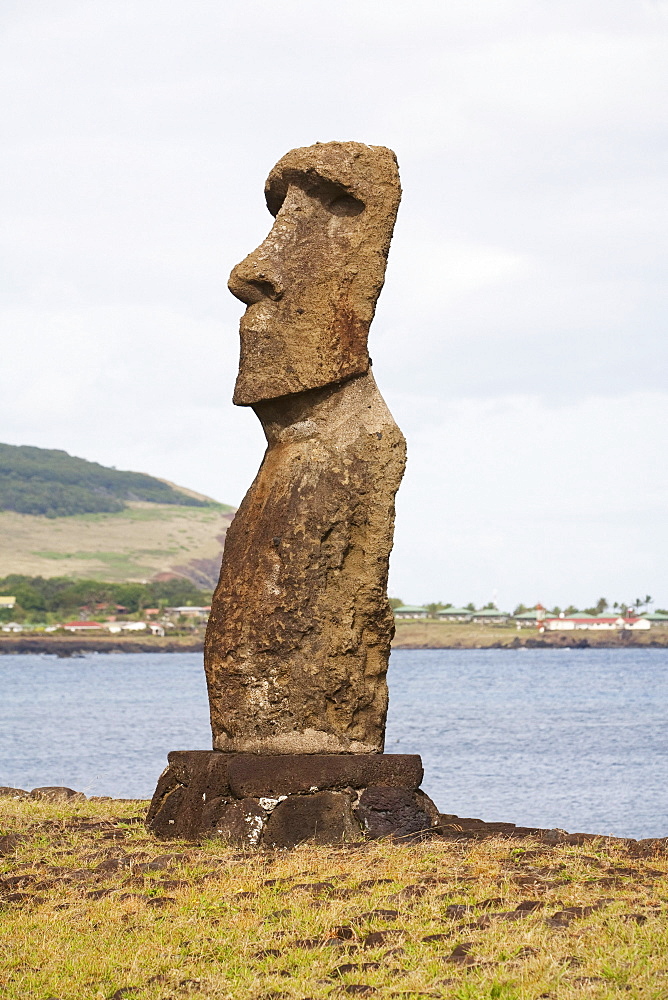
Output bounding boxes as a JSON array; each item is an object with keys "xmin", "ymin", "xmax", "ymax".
[{"xmin": 0, "ymin": 445, "xmax": 234, "ymax": 588}]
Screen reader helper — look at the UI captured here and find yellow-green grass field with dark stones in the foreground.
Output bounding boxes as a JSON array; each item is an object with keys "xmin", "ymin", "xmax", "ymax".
[{"xmin": 0, "ymin": 798, "xmax": 668, "ymax": 1000}]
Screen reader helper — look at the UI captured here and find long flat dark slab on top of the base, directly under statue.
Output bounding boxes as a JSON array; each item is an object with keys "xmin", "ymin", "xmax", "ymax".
[{"xmin": 228, "ymin": 754, "xmax": 423, "ymax": 797}]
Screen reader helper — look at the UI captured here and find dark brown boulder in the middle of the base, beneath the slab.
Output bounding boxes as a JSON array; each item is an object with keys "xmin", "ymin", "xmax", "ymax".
[{"xmin": 262, "ymin": 792, "xmax": 362, "ymax": 847}]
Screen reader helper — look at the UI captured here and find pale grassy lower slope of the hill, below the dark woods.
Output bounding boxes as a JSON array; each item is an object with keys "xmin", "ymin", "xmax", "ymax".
[{"xmin": 0, "ymin": 503, "xmax": 233, "ymax": 586}]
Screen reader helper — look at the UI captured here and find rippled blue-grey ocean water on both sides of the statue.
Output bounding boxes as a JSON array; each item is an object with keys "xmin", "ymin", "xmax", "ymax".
[{"xmin": 0, "ymin": 649, "xmax": 668, "ymax": 837}]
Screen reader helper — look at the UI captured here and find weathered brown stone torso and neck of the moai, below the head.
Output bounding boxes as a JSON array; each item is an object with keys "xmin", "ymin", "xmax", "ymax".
[{"xmin": 205, "ymin": 373, "xmax": 405, "ymax": 753}]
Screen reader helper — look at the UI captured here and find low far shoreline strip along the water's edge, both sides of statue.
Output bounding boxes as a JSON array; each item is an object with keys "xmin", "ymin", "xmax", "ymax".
[{"xmin": 0, "ymin": 621, "xmax": 668, "ymax": 658}]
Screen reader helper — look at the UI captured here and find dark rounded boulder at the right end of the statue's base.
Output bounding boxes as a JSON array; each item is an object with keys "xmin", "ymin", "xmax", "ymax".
[{"xmin": 355, "ymin": 787, "xmax": 439, "ymax": 839}]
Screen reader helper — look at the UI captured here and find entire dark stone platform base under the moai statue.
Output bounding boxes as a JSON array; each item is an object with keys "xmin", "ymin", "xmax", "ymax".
[{"xmin": 146, "ymin": 750, "xmax": 439, "ymax": 848}]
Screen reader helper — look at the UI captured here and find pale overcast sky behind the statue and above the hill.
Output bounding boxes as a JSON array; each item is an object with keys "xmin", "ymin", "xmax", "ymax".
[{"xmin": 0, "ymin": 0, "xmax": 668, "ymax": 608}]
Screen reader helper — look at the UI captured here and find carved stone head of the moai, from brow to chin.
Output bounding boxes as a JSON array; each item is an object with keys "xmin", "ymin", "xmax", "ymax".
[{"xmin": 229, "ymin": 142, "xmax": 401, "ymax": 406}]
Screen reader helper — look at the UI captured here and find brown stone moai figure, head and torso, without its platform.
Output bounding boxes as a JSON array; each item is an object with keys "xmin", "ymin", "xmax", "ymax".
[{"xmin": 205, "ymin": 143, "xmax": 405, "ymax": 754}]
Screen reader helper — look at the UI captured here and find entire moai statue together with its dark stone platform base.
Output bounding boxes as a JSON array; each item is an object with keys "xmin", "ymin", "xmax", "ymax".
[{"xmin": 147, "ymin": 142, "xmax": 438, "ymax": 846}]
